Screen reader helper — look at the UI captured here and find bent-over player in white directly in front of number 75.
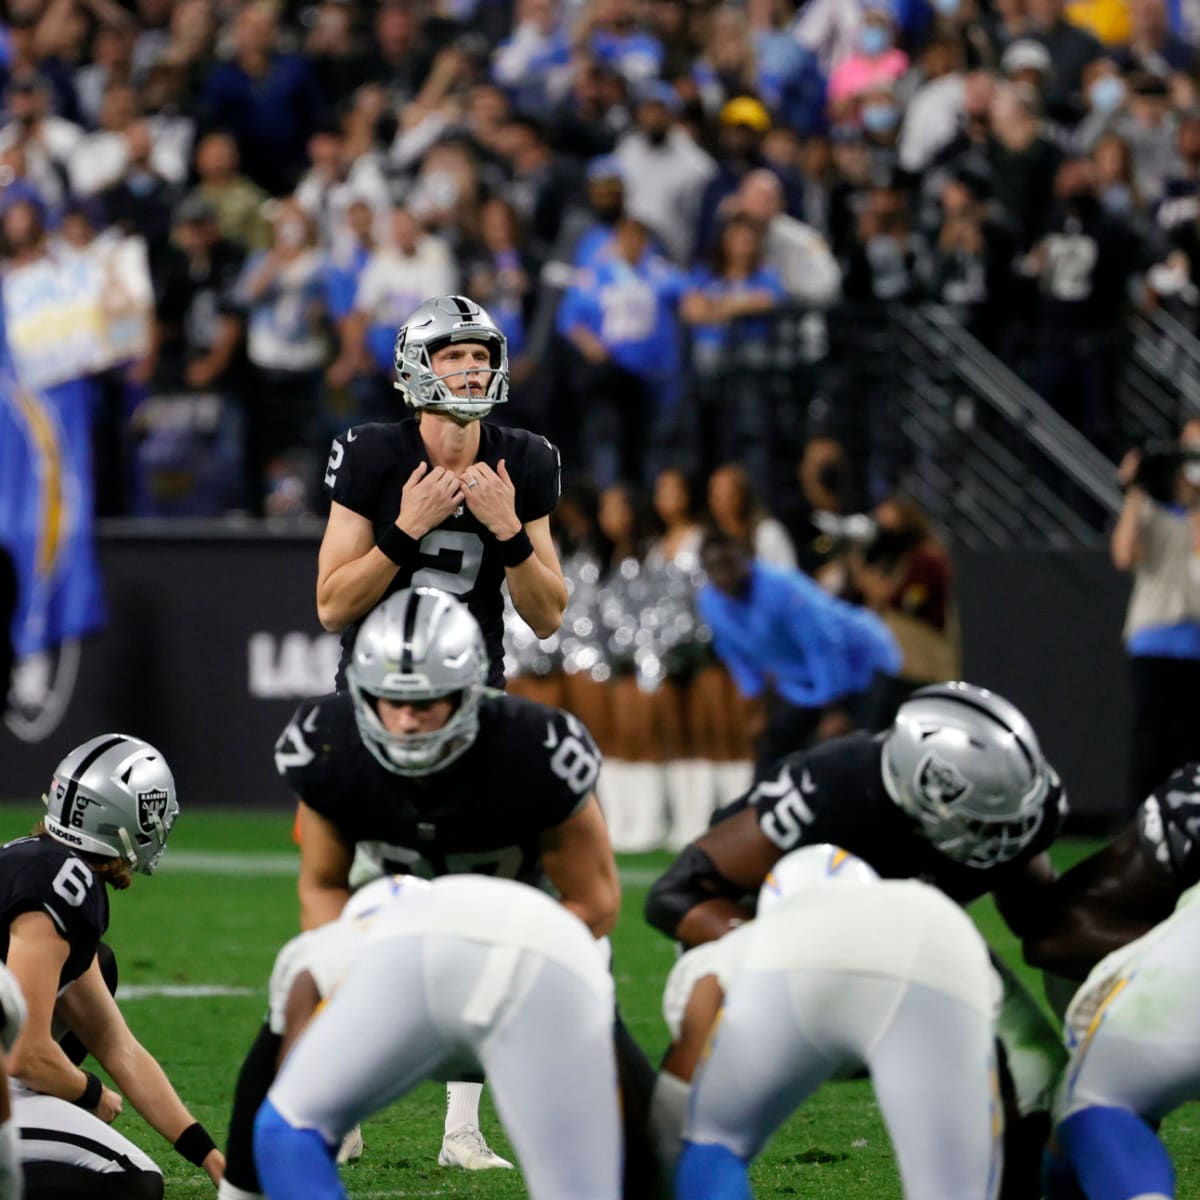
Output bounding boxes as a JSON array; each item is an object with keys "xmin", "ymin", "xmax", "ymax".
[{"xmin": 655, "ymin": 845, "xmax": 1002, "ymax": 1200}]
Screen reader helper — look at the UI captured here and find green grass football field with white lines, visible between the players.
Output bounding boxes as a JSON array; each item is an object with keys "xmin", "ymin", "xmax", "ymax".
[{"xmin": 0, "ymin": 806, "xmax": 1200, "ymax": 1200}]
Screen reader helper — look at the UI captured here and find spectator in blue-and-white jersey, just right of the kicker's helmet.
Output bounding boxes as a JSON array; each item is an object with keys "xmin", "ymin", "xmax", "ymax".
[{"xmin": 558, "ymin": 217, "xmax": 683, "ymax": 486}]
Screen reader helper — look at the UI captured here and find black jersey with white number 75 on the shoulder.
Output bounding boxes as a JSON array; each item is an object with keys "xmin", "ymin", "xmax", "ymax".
[{"xmin": 714, "ymin": 733, "xmax": 1066, "ymax": 904}]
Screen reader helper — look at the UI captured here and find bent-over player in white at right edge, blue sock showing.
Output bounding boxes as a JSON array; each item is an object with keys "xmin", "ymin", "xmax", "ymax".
[{"xmin": 1045, "ymin": 886, "xmax": 1200, "ymax": 1200}]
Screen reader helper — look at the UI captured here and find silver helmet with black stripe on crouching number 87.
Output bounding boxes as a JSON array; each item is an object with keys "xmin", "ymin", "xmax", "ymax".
[{"xmin": 346, "ymin": 588, "xmax": 487, "ymax": 775}]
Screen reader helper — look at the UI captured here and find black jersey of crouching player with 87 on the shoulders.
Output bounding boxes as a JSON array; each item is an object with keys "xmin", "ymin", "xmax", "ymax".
[{"xmin": 275, "ymin": 690, "xmax": 600, "ymax": 886}]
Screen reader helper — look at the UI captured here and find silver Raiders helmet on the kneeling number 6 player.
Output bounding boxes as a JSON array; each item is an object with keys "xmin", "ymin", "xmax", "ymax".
[{"xmin": 43, "ymin": 733, "xmax": 179, "ymax": 875}]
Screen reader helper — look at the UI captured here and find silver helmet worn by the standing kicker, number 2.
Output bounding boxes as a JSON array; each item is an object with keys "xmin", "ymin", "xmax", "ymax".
[{"xmin": 392, "ymin": 296, "xmax": 509, "ymax": 421}]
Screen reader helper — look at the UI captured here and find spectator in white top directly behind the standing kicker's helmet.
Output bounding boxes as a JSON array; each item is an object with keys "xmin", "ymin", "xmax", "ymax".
[{"xmin": 329, "ymin": 208, "xmax": 458, "ymax": 389}]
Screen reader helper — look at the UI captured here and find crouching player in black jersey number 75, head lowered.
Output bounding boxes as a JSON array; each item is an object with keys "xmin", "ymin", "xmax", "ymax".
[{"xmin": 646, "ymin": 683, "xmax": 1066, "ymax": 1196}]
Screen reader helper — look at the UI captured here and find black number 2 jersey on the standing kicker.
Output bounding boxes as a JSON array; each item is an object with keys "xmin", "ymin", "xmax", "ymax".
[{"xmin": 324, "ymin": 420, "xmax": 559, "ymax": 691}]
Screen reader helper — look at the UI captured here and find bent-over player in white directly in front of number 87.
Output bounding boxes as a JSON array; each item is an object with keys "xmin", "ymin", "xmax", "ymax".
[{"xmin": 254, "ymin": 875, "xmax": 620, "ymax": 1200}]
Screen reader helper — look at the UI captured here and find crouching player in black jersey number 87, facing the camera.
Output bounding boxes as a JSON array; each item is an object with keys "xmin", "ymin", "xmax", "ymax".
[{"xmin": 223, "ymin": 588, "xmax": 620, "ymax": 1200}]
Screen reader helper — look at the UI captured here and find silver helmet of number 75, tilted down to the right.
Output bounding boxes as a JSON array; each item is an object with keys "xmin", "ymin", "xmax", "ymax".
[{"xmin": 883, "ymin": 683, "xmax": 1061, "ymax": 869}]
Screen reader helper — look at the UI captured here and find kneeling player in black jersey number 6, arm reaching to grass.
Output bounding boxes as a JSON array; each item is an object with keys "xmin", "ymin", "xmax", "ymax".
[{"xmin": 0, "ymin": 733, "xmax": 224, "ymax": 1200}]
